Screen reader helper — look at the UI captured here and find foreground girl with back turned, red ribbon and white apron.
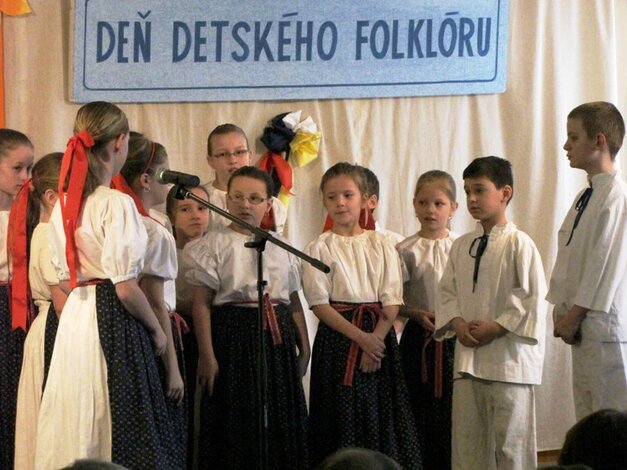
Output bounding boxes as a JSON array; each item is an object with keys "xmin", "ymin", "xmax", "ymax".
[{"xmin": 35, "ymin": 102, "xmax": 177, "ymax": 469}]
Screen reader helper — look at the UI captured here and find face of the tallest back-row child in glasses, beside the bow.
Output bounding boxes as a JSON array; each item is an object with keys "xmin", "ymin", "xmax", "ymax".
[{"xmin": 207, "ymin": 132, "xmax": 250, "ymax": 186}]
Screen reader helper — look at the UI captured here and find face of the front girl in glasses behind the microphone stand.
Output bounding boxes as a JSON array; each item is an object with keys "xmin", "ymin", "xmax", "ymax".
[{"xmin": 226, "ymin": 176, "xmax": 272, "ymax": 227}]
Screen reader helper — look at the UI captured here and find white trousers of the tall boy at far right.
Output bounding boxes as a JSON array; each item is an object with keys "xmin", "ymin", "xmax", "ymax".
[{"xmin": 572, "ymin": 335, "xmax": 627, "ymax": 421}]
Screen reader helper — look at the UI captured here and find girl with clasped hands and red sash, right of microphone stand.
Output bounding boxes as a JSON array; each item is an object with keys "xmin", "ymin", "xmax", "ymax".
[{"xmin": 303, "ymin": 163, "xmax": 422, "ymax": 469}]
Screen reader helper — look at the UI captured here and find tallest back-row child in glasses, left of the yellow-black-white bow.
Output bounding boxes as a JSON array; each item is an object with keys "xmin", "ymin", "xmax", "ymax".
[{"xmin": 204, "ymin": 124, "xmax": 287, "ymax": 234}]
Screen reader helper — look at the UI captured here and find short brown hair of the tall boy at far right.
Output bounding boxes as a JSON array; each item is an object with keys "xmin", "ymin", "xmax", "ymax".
[{"xmin": 568, "ymin": 101, "xmax": 625, "ymax": 160}]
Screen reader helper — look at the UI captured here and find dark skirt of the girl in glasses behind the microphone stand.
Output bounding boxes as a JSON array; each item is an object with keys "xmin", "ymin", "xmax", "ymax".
[{"xmin": 198, "ymin": 305, "xmax": 309, "ymax": 470}]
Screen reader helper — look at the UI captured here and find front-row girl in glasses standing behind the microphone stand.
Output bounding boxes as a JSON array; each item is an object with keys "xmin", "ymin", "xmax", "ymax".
[{"xmin": 184, "ymin": 167, "xmax": 309, "ymax": 469}]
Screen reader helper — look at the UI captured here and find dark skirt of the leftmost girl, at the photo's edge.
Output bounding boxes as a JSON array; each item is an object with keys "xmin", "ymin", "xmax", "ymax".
[{"xmin": 0, "ymin": 284, "xmax": 26, "ymax": 469}]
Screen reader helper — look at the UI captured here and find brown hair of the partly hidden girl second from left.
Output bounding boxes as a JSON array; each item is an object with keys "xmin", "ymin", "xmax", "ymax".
[{"xmin": 26, "ymin": 152, "xmax": 63, "ymax": 246}]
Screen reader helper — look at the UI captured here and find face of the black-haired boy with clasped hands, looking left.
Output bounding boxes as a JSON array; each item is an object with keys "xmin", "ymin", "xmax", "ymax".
[{"xmin": 464, "ymin": 176, "xmax": 511, "ymax": 224}]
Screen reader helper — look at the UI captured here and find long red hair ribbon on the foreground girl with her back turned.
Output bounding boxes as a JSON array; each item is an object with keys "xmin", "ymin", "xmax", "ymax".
[{"xmin": 59, "ymin": 131, "xmax": 95, "ymax": 288}]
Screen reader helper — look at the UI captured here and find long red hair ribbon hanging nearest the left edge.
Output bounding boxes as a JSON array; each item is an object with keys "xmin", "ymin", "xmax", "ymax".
[{"xmin": 7, "ymin": 180, "xmax": 35, "ymax": 331}]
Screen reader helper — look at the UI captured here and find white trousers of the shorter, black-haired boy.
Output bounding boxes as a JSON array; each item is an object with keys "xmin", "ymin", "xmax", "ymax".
[{"xmin": 452, "ymin": 378, "xmax": 537, "ymax": 470}]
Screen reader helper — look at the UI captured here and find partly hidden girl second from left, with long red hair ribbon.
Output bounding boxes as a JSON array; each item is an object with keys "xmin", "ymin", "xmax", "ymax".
[{"xmin": 11, "ymin": 152, "xmax": 67, "ymax": 469}]
